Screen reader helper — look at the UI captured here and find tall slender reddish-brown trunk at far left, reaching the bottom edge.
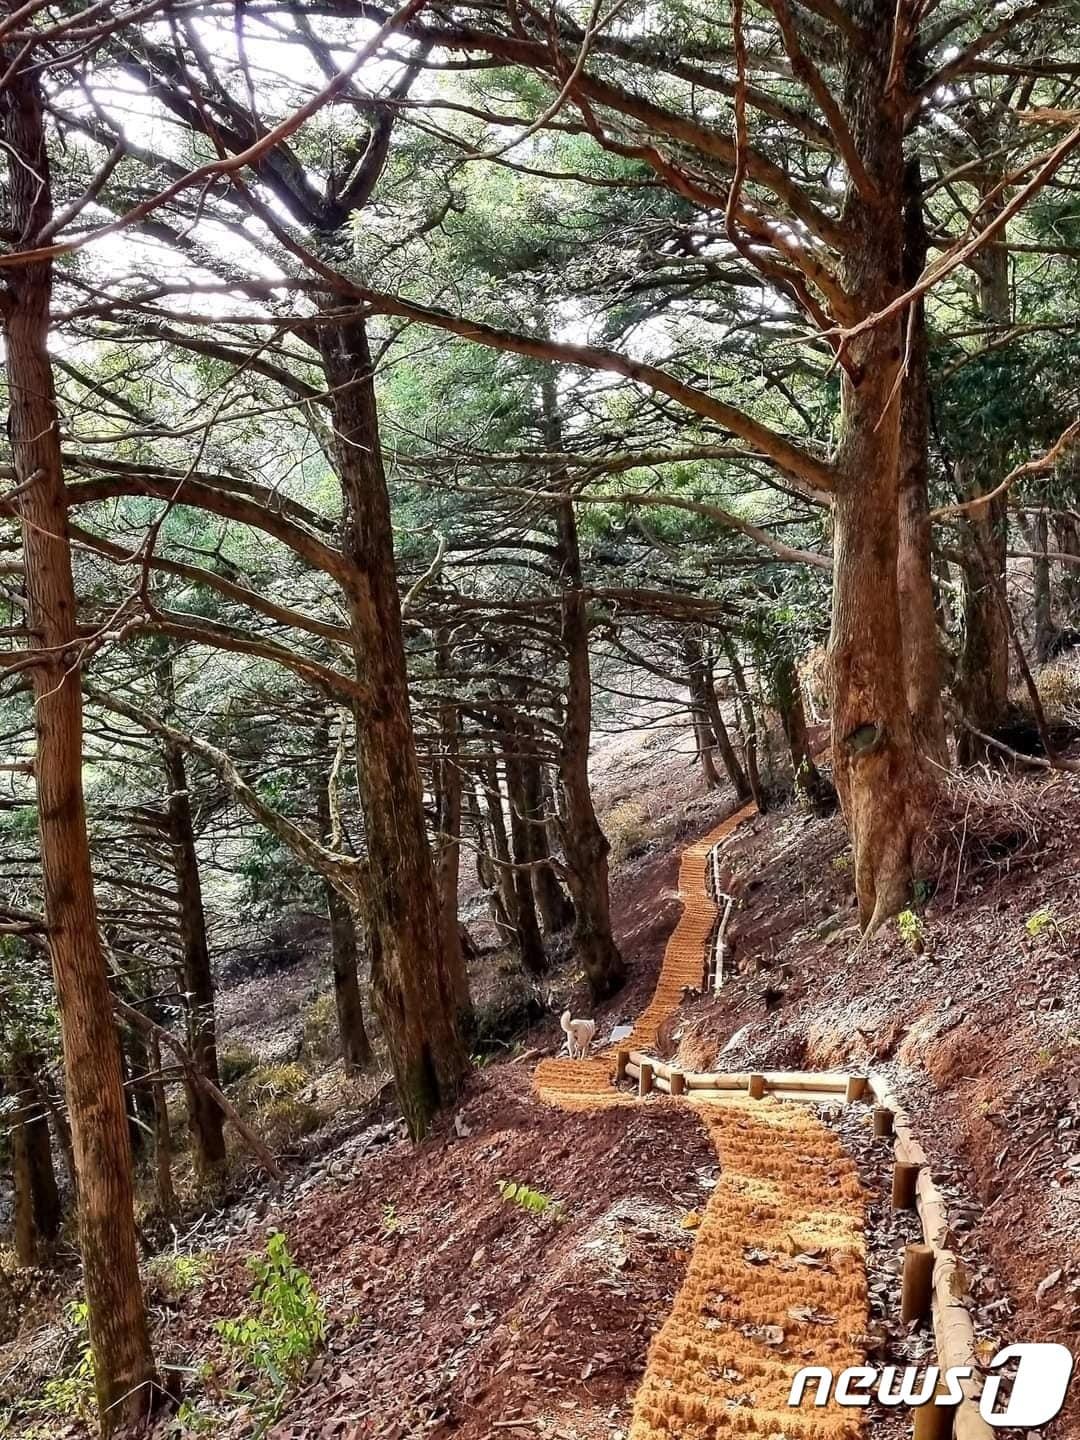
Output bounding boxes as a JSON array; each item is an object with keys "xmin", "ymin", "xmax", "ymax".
[{"xmin": 0, "ymin": 53, "xmax": 154, "ymax": 1436}]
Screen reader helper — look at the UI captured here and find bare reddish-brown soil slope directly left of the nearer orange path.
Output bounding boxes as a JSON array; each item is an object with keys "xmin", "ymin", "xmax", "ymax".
[{"xmin": 152, "ymin": 1066, "xmax": 716, "ymax": 1440}]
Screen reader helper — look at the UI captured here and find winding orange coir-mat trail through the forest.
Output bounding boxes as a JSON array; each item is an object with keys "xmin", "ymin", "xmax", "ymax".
[{"xmin": 534, "ymin": 805, "xmax": 868, "ymax": 1440}]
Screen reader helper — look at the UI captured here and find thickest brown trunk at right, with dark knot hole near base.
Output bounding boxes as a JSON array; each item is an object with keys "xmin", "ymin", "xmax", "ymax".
[{"xmin": 829, "ymin": 19, "xmax": 924, "ymax": 930}]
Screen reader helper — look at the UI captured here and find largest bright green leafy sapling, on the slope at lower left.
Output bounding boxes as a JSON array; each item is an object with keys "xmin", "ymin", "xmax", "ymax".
[{"xmin": 215, "ymin": 1230, "xmax": 327, "ymax": 1434}]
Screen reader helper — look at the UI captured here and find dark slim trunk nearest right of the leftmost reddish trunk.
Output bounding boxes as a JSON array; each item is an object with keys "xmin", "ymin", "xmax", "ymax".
[{"xmin": 166, "ymin": 737, "xmax": 226, "ymax": 1179}]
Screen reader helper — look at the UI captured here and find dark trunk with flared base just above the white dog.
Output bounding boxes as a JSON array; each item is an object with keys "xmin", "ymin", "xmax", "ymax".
[{"xmin": 543, "ymin": 374, "xmax": 626, "ymax": 1001}]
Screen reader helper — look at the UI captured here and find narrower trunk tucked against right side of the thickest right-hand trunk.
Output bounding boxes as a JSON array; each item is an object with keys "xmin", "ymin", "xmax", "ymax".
[{"xmin": 897, "ymin": 158, "xmax": 949, "ymax": 769}]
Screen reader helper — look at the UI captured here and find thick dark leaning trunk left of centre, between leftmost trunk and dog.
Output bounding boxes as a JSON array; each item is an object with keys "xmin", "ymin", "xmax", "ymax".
[{"xmin": 318, "ymin": 314, "xmax": 467, "ymax": 1138}]
